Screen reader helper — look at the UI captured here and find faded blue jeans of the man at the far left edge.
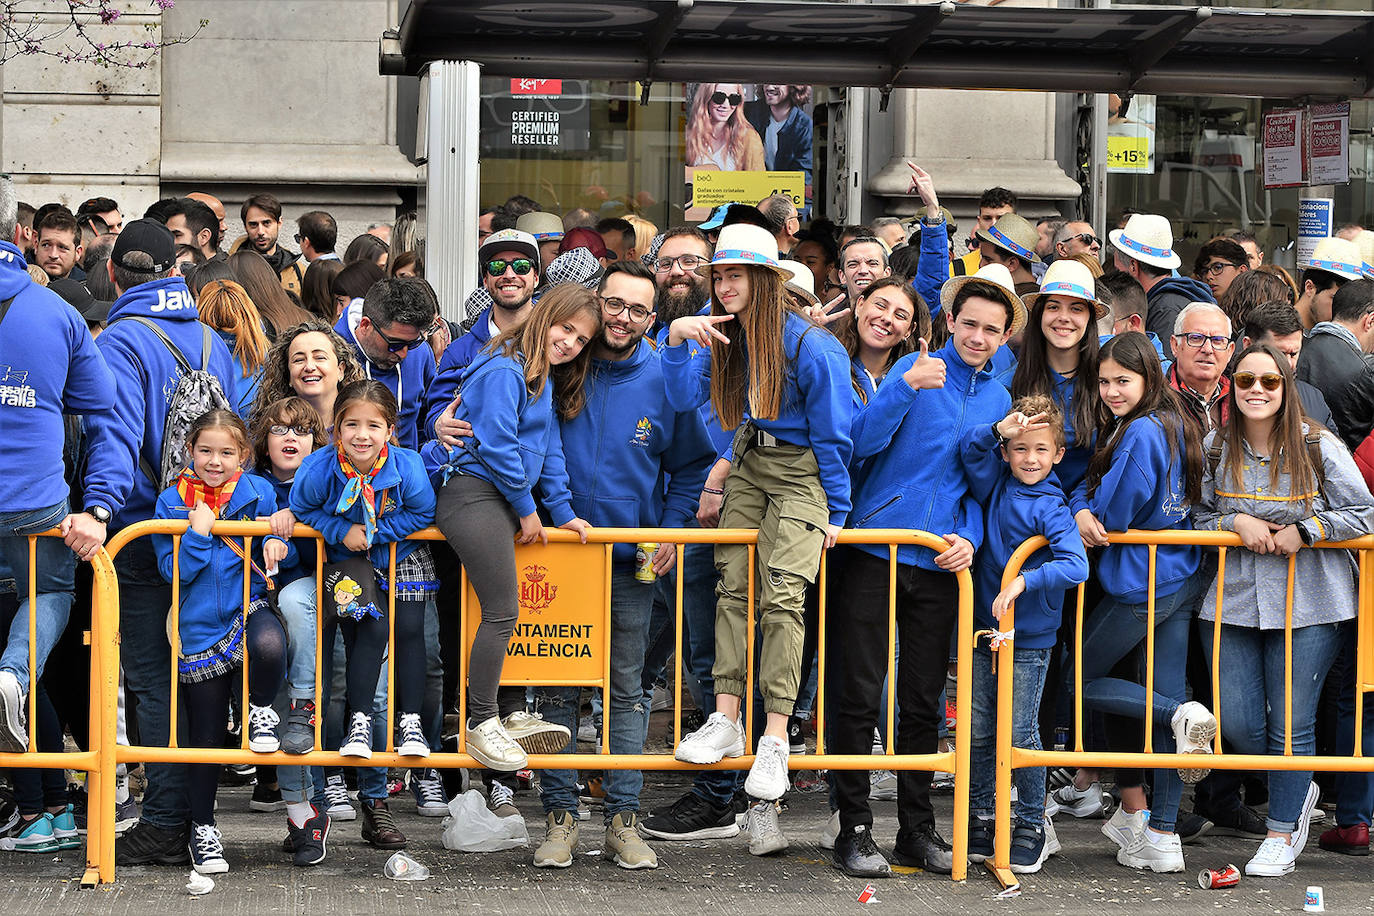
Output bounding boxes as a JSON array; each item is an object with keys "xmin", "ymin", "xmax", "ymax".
[{"xmin": 0, "ymin": 500, "xmax": 75, "ymax": 692}]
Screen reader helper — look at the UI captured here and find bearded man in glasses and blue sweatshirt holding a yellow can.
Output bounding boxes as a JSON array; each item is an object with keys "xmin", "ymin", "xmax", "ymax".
[{"xmin": 534, "ymin": 260, "xmax": 716, "ymax": 868}]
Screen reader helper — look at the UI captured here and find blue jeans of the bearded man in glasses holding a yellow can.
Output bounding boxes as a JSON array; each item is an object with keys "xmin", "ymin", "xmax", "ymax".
[{"xmin": 534, "ymin": 570, "xmax": 654, "ymax": 823}]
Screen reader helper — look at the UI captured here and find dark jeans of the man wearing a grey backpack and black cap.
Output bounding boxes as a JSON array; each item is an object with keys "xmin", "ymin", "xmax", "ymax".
[{"xmin": 114, "ymin": 537, "xmax": 191, "ymax": 831}]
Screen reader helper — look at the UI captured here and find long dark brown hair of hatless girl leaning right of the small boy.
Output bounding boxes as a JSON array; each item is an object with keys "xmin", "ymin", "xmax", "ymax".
[{"xmin": 1087, "ymin": 331, "xmax": 1202, "ymax": 504}]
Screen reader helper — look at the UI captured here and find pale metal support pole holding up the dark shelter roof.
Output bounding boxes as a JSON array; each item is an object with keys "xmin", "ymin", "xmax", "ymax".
[{"xmin": 425, "ymin": 60, "xmax": 482, "ymax": 321}]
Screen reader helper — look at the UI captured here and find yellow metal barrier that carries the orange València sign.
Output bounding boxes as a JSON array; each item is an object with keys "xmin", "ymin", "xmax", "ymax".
[{"xmin": 94, "ymin": 520, "xmax": 973, "ymax": 882}]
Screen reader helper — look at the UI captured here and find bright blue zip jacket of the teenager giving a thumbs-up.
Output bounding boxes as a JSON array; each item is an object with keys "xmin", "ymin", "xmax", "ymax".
[{"xmin": 852, "ymin": 341, "xmax": 1011, "ymax": 570}]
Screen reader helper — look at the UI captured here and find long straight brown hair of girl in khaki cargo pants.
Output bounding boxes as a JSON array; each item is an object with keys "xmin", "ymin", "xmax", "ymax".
[{"xmin": 710, "ymin": 264, "xmax": 796, "ymax": 430}]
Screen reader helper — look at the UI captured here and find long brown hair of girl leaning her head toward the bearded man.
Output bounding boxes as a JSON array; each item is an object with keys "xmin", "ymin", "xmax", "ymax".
[{"xmin": 486, "ymin": 283, "xmax": 602, "ymax": 420}]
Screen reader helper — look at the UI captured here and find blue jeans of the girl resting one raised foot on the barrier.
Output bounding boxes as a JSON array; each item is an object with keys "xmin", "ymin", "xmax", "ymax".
[{"xmin": 1081, "ymin": 577, "xmax": 1198, "ymax": 834}]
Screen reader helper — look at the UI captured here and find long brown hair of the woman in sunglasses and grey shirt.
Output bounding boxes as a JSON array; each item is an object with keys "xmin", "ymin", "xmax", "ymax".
[{"xmin": 1217, "ymin": 341, "xmax": 1325, "ymax": 508}]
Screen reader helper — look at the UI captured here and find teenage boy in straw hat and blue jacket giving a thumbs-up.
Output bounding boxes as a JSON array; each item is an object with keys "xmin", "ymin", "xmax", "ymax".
[{"xmin": 829, "ymin": 265, "xmax": 1025, "ymax": 878}]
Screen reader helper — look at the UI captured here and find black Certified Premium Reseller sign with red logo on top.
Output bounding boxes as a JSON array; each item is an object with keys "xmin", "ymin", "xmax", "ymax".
[{"xmin": 481, "ymin": 77, "xmax": 591, "ymax": 155}]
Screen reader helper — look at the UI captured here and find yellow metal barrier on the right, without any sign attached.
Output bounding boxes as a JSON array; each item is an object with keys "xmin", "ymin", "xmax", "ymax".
[{"xmin": 994, "ymin": 530, "xmax": 1374, "ymax": 887}]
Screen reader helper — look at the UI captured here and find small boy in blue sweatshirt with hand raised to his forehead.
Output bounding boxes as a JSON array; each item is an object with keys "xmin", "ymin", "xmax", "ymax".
[{"xmin": 962, "ymin": 396, "xmax": 1088, "ymax": 873}]
